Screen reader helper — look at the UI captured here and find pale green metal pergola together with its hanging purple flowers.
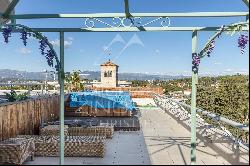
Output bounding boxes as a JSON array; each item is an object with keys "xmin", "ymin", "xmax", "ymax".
[{"xmin": 0, "ymin": 0, "xmax": 249, "ymax": 164}]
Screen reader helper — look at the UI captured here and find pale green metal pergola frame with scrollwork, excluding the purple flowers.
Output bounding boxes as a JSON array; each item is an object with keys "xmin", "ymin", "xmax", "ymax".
[{"xmin": 0, "ymin": 0, "xmax": 249, "ymax": 165}]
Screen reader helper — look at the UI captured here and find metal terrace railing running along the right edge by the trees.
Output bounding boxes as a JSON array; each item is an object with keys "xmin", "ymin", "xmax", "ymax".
[{"xmin": 154, "ymin": 94, "xmax": 249, "ymax": 164}]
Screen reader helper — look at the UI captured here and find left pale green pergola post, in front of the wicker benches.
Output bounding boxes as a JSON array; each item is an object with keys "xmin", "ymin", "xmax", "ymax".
[{"xmin": 59, "ymin": 32, "xmax": 65, "ymax": 165}]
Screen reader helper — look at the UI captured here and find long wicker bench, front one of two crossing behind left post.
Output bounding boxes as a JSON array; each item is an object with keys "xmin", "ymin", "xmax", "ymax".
[{"xmin": 18, "ymin": 135, "xmax": 105, "ymax": 157}]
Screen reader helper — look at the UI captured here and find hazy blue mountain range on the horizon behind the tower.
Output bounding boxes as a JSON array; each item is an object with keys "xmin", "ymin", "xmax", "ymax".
[{"xmin": 0, "ymin": 69, "xmax": 186, "ymax": 80}]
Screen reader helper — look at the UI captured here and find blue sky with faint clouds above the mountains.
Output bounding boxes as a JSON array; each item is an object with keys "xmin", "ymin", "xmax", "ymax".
[{"xmin": 0, "ymin": 0, "xmax": 249, "ymax": 75}]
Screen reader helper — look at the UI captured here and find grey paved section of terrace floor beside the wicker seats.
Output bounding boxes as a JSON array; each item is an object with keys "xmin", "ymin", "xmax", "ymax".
[{"xmin": 25, "ymin": 131, "xmax": 151, "ymax": 165}]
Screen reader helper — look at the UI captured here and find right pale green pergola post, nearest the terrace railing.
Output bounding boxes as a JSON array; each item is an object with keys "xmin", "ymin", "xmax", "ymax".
[{"xmin": 191, "ymin": 31, "xmax": 198, "ymax": 165}]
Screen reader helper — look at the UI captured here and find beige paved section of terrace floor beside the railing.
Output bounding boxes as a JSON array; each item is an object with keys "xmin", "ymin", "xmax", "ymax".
[{"xmin": 141, "ymin": 109, "xmax": 236, "ymax": 165}]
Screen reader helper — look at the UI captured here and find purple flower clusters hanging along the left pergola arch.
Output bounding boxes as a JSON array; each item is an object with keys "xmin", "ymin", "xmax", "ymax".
[{"xmin": 2, "ymin": 25, "xmax": 59, "ymax": 71}]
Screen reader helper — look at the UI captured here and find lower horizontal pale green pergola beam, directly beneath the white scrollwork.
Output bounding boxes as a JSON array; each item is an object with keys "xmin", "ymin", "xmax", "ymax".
[{"xmin": 0, "ymin": 27, "xmax": 249, "ymax": 32}]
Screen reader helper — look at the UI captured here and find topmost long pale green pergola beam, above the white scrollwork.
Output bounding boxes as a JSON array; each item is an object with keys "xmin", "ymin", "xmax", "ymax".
[{"xmin": 0, "ymin": 12, "xmax": 249, "ymax": 19}]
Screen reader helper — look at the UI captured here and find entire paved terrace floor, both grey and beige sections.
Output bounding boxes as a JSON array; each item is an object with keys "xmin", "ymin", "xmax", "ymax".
[{"xmin": 25, "ymin": 109, "xmax": 248, "ymax": 165}]
